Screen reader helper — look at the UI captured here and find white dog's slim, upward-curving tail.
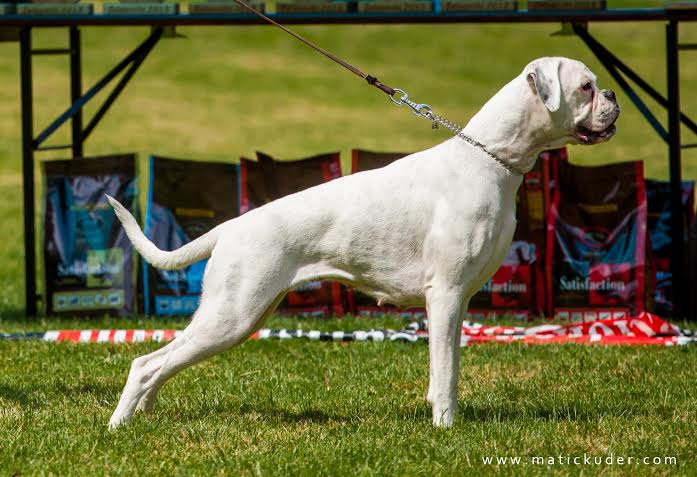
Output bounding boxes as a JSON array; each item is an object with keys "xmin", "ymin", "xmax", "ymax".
[{"xmin": 106, "ymin": 195, "xmax": 218, "ymax": 270}]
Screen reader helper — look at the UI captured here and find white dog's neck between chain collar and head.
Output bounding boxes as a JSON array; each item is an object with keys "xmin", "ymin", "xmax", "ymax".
[{"xmin": 464, "ymin": 75, "xmax": 551, "ymax": 172}]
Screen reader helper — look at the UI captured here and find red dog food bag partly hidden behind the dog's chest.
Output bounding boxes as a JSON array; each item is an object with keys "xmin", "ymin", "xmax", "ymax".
[{"xmin": 468, "ymin": 149, "xmax": 568, "ymax": 320}]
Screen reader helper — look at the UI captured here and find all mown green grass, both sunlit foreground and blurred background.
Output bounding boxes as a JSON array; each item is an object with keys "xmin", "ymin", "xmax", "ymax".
[{"xmin": 0, "ymin": 1, "xmax": 697, "ymax": 476}]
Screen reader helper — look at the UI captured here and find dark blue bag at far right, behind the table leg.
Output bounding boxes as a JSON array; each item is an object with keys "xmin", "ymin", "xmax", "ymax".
[{"xmin": 646, "ymin": 180, "xmax": 695, "ymax": 316}]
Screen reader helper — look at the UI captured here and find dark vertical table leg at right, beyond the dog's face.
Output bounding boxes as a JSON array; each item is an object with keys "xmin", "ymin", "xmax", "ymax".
[{"xmin": 666, "ymin": 20, "xmax": 688, "ymax": 318}]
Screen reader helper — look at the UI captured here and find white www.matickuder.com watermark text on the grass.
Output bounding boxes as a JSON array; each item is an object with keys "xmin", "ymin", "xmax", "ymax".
[{"xmin": 482, "ymin": 453, "xmax": 678, "ymax": 467}]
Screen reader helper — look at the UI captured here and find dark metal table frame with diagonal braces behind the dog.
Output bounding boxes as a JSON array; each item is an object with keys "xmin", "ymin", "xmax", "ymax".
[{"xmin": 8, "ymin": 8, "xmax": 697, "ymax": 318}]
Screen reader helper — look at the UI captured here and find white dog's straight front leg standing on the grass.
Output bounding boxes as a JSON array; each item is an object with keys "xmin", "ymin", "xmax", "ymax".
[{"xmin": 426, "ymin": 288, "xmax": 465, "ymax": 427}]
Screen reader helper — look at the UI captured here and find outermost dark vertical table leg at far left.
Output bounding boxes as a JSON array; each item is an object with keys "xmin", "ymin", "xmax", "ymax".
[{"xmin": 19, "ymin": 27, "xmax": 37, "ymax": 316}]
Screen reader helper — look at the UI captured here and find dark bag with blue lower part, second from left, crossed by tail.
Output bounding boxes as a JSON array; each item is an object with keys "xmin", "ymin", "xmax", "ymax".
[{"xmin": 143, "ymin": 157, "xmax": 239, "ymax": 315}]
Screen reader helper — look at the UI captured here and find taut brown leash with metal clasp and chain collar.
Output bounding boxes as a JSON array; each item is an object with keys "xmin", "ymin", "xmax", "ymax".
[{"xmin": 223, "ymin": 0, "xmax": 525, "ymax": 176}]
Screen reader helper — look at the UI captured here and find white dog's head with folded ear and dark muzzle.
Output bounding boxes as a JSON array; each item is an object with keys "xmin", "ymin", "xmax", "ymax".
[{"xmin": 523, "ymin": 58, "xmax": 620, "ymax": 148}]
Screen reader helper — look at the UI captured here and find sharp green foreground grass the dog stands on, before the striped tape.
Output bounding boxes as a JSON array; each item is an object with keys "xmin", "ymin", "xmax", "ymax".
[{"xmin": 0, "ymin": 314, "xmax": 697, "ymax": 475}]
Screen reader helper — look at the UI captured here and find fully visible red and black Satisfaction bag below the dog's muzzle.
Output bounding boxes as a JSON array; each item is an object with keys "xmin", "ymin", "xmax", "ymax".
[{"xmin": 546, "ymin": 161, "xmax": 651, "ymax": 316}]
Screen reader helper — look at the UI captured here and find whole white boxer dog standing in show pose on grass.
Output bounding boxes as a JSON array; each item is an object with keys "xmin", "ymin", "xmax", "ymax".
[{"xmin": 109, "ymin": 58, "xmax": 619, "ymax": 428}]
